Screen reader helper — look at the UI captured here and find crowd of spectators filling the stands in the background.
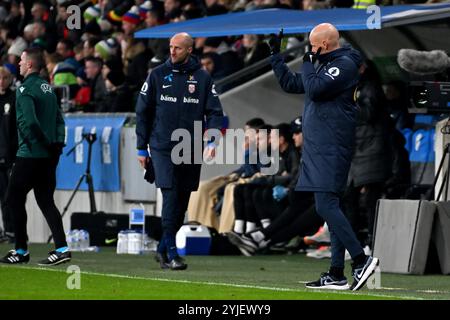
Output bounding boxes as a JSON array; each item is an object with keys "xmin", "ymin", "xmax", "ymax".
[{"xmin": 0, "ymin": 0, "xmax": 446, "ymax": 112}]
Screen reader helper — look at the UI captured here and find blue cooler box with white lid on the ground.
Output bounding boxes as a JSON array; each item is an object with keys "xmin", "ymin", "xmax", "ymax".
[{"xmin": 176, "ymin": 225, "xmax": 211, "ymax": 256}]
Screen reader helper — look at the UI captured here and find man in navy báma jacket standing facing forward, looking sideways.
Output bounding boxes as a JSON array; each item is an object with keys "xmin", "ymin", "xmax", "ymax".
[{"xmin": 136, "ymin": 33, "xmax": 223, "ymax": 270}]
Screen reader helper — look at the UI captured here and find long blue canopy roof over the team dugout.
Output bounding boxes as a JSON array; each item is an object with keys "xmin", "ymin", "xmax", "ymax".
[{"xmin": 134, "ymin": 3, "xmax": 450, "ymax": 38}]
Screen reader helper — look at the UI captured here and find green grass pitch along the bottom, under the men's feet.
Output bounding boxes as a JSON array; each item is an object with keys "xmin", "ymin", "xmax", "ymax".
[{"xmin": 0, "ymin": 244, "xmax": 450, "ymax": 300}]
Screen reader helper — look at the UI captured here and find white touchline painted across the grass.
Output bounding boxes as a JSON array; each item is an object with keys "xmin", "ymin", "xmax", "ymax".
[{"xmin": 0, "ymin": 266, "xmax": 426, "ymax": 300}]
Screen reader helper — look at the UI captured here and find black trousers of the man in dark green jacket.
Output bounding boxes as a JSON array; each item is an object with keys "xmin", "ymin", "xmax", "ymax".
[{"xmin": 6, "ymin": 157, "xmax": 67, "ymax": 250}]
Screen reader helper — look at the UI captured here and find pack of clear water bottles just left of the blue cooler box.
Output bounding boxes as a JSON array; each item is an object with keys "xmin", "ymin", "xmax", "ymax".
[{"xmin": 116, "ymin": 230, "xmax": 156, "ymax": 254}]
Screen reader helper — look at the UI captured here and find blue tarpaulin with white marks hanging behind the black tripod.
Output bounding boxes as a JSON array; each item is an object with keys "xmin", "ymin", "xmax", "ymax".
[{"xmin": 56, "ymin": 116, "xmax": 126, "ymax": 192}]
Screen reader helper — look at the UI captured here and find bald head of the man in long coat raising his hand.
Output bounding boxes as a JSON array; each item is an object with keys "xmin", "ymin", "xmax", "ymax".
[{"xmin": 309, "ymin": 23, "xmax": 339, "ymax": 54}]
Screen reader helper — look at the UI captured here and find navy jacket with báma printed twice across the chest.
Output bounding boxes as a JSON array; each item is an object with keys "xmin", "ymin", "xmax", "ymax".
[{"xmin": 136, "ymin": 56, "xmax": 223, "ymax": 190}]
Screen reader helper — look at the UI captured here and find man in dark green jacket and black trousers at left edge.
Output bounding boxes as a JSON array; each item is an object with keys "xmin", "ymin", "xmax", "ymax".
[{"xmin": 0, "ymin": 48, "xmax": 71, "ymax": 265}]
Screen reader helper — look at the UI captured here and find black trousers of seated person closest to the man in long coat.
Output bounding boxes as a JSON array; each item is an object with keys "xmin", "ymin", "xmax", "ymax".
[{"xmin": 262, "ymin": 190, "xmax": 324, "ymax": 243}]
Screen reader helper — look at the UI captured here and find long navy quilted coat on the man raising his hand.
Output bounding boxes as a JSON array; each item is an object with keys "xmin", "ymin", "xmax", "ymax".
[{"xmin": 271, "ymin": 47, "xmax": 361, "ymax": 193}]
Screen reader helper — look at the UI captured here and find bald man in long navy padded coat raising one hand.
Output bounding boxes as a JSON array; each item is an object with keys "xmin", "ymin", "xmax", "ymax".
[{"xmin": 270, "ymin": 23, "xmax": 379, "ymax": 290}]
